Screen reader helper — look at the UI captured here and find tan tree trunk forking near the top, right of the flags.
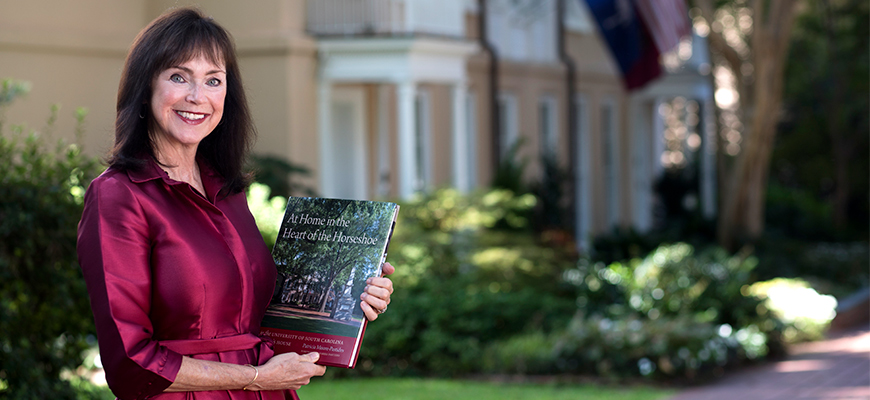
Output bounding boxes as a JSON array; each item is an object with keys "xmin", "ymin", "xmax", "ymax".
[{"xmin": 698, "ymin": 0, "xmax": 797, "ymax": 250}]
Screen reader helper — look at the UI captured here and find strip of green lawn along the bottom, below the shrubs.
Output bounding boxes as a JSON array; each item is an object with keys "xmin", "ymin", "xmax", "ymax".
[{"xmin": 299, "ymin": 378, "xmax": 674, "ymax": 400}]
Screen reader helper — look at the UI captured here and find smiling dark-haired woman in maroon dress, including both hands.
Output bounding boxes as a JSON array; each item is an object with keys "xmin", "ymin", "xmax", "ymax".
[{"xmin": 78, "ymin": 8, "xmax": 393, "ymax": 399}]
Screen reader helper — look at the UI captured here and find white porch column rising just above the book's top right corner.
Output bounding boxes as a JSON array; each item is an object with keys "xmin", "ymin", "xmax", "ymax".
[{"xmin": 397, "ymin": 81, "xmax": 418, "ymax": 199}]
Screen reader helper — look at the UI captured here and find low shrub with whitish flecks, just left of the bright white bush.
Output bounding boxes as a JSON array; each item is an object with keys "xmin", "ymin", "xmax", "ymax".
[{"xmin": 555, "ymin": 243, "xmax": 783, "ymax": 378}]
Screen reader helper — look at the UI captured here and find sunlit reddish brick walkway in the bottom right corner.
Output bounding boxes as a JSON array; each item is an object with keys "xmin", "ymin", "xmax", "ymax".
[{"xmin": 670, "ymin": 326, "xmax": 870, "ymax": 400}]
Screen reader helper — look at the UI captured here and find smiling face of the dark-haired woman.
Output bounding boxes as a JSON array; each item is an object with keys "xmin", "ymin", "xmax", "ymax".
[{"xmin": 151, "ymin": 57, "xmax": 227, "ymax": 151}]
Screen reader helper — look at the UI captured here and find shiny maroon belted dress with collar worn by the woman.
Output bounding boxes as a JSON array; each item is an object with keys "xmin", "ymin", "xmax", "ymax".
[{"xmin": 78, "ymin": 161, "xmax": 297, "ymax": 400}]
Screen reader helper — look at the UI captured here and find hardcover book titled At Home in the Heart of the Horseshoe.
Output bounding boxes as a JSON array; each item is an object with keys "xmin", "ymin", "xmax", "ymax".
[{"xmin": 261, "ymin": 197, "xmax": 399, "ymax": 368}]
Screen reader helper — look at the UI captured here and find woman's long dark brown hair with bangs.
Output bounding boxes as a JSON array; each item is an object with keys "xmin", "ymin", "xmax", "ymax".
[{"xmin": 108, "ymin": 8, "xmax": 256, "ymax": 195}]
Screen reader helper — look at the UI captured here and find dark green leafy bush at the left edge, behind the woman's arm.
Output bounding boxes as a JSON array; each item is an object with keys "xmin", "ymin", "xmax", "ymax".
[{"xmin": 0, "ymin": 81, "xmax": 99, "ymax": 399}]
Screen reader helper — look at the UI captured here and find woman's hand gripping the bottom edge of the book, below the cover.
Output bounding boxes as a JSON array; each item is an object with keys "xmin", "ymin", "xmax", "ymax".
[{"xmin": 248, "ymin": 353, "xmax": 326, "ymax": 390}]
